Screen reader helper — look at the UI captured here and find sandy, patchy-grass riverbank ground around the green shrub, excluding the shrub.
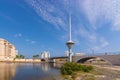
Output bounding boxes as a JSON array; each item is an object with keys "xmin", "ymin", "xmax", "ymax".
[{"xmin": 63, "ymin": 65, "xmax": 120, "ymax": 80}]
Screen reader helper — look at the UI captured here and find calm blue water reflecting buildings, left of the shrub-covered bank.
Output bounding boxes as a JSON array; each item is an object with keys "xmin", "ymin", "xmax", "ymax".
[{"xmin": 0, "ymin": 63, "xmax": 61, "ymax": 80}]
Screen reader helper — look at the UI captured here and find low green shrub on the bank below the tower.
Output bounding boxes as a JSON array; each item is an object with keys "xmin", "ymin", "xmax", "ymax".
[{"xmin": 61, "ymin": 62, "xmax": 93, "ymax": 75}]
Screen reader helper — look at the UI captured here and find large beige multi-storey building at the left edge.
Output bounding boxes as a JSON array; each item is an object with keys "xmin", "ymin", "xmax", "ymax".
[{"xmin": 0, "ymin": 38, "xmax": 18, "ymax": 59}]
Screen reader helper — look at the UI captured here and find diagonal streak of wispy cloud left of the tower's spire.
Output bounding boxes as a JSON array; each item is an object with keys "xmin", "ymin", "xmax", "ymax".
[{"xmin": 26, "ymin": 0, "xmax": 66, "ymax": 30}]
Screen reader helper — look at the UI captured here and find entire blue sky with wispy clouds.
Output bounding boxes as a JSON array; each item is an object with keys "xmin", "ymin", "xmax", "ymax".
[{"xmin": 0, "ymin": 0, "xmax": 120, "ymax": 58}]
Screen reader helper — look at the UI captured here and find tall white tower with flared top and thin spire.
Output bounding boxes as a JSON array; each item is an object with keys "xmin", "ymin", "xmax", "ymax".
[{"xmin": 66, "ymin": 15, "xmax": 75, "ymax": 62}]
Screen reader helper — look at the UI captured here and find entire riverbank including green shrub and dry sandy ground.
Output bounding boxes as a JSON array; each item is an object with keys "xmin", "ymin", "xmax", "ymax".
[{"xmin": 61, "ymin": 62, "xmax": 120, "ymax": 80}]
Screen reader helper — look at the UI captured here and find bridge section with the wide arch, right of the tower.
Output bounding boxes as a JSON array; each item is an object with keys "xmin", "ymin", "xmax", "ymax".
[{"xmin": 73, "ymin": 54, "xmax": 120, "ymax": 65}]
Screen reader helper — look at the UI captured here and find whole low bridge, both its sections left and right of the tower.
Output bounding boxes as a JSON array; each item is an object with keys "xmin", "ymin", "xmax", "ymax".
[{"xmin": 49, "ymin": 53, "xmax": 120, "ymax": 65}]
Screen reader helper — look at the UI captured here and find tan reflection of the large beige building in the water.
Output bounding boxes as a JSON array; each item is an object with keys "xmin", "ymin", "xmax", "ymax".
[{"xmin": 0, "ymin": 63, "xmax": 16, "ymax": 80}]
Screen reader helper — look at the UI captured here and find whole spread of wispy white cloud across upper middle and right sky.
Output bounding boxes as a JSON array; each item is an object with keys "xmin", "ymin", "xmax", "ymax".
[{"xmin": 25, "ymin": 0, "xmax": 110, "ymax": 50}]
